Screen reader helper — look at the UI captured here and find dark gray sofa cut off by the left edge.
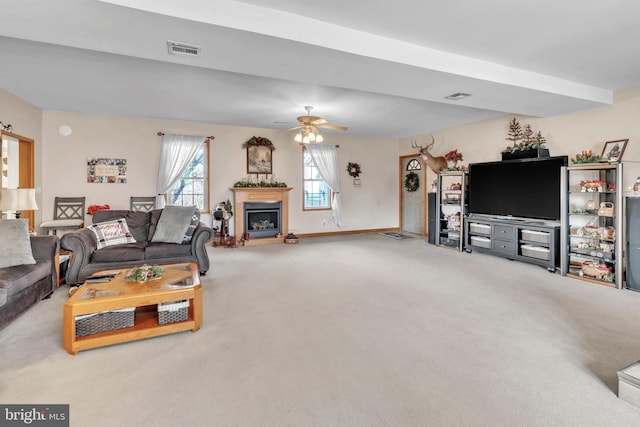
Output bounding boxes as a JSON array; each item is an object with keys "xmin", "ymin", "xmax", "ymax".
[{"xmin": 0, "ymin": 236, "xmax": 60, "ymax": 329}]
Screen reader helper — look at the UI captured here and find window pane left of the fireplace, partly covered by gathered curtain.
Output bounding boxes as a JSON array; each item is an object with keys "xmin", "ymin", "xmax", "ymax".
[{"xmin": 167, "ymin": 139, "xmax": 210, "ymax": 212}]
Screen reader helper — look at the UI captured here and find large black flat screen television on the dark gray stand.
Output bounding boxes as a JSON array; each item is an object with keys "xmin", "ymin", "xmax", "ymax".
[{"xmin": 469, "ymin": 156, "xmax": 568, "ymax": 221}]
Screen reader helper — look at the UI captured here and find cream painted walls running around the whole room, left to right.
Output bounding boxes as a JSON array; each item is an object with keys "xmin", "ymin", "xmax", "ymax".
[{"xmin": 6, "ymin": 88, "xmax": 640, "ymax": 234}]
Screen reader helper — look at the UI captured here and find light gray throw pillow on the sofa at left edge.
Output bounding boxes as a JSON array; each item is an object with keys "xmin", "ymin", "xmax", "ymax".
[{"xmin": 0, "ymin": 219, "xmax": 36, "ymax": 268}]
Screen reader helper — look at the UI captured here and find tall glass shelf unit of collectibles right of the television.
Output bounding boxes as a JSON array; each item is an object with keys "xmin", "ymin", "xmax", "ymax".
[{"xmin": 561, "ymin": 163, "xmax": 624, "ymax": 289}]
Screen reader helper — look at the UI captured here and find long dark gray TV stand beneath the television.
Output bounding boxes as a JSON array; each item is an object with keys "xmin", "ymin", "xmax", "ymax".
[{"xmin": 464, "ymin": 215, "xmax": 560, "ymax": 272}]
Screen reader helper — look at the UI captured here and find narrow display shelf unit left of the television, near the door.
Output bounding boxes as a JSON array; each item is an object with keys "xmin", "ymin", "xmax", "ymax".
[{"xmin": 435, "ymin": 171, "xmax": 468, "ymax": 251}]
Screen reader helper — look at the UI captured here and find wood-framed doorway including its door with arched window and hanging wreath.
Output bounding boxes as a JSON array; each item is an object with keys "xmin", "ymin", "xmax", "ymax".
[{"xmin": 400, "ymin": 154, "xmax": 426, "ymax": 236}]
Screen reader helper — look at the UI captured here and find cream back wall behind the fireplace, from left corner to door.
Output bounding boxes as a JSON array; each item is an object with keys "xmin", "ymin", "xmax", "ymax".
[{"xmin": 42, "ymin": 111, "xmax": 398, "ymax": 234}]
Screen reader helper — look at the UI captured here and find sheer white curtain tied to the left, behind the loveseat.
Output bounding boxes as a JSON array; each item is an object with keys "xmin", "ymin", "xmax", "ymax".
[{"xmin": 156, "ymin": 134, "xmax": 205, "ymax": 209}]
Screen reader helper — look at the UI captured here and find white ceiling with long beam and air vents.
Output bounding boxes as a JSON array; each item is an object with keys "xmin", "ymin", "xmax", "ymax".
[{"xmin": 0, "ymin": 0, "xmax": 640, "ymax": 138}]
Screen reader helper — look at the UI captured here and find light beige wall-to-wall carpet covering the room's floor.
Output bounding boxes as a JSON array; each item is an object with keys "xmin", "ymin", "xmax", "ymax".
[{"xmin": 0, "ymin": 233, "xmax": 640, "ymax": 427}]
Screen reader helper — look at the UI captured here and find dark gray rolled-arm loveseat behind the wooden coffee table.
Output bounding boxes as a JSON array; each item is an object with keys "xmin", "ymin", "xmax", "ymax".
[{"xmin": 60, "ymin": 206, "xmax": 214, "ymax": 285}]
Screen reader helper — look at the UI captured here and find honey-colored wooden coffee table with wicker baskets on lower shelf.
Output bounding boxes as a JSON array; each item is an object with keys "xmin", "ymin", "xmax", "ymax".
[{"xmin": 63, "ymin": 263, "xmax": 202, "ymax": 354}]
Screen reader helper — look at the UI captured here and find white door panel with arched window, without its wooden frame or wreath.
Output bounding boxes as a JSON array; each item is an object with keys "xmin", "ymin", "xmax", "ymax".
[{"xmin": 400, "ymin": 156, "xmax": 425, "ymax": 235}]
